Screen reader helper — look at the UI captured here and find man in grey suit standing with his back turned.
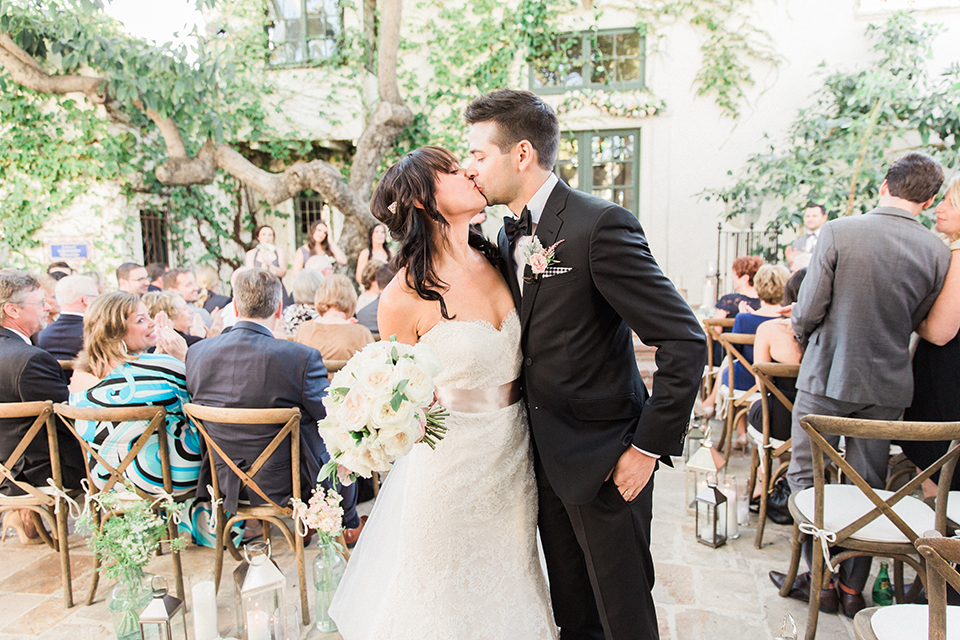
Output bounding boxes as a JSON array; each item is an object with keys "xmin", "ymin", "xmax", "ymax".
[{"xmin": 770, "ymin": 152, "xmax": 950, "ymax": 618}]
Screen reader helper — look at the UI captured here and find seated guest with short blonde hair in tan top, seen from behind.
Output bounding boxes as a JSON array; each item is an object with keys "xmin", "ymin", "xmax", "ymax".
[{"xmin": 296, "ymin": 273, "xmax": 373, "ymax": 361}]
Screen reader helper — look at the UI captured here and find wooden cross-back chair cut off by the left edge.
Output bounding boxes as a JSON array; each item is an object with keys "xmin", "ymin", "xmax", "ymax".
[{"xmin": 0, "ymin": 400, "xmax": 73, "ymax": 608}]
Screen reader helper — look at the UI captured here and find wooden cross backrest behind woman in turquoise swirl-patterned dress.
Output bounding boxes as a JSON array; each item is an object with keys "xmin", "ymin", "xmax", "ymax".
[{"xmin": 53, "ymin": 403, "xmax": 173, "ymax": 499}]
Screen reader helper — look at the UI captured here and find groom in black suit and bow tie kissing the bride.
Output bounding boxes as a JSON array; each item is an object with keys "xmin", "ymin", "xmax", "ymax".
[{"xmin": 465, "ymin": 89, "xmax": 706, "ymax": 640}]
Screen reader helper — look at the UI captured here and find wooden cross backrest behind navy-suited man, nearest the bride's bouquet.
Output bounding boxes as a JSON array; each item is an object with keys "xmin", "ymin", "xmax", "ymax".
[{"xmin": 183, "ymin": 402, "xmax": 300, "ymax": 515}]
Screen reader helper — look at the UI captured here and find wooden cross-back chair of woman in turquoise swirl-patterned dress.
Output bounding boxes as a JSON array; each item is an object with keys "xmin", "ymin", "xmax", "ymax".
[{"xmin": 53, "ymin": 403, "xmax": 186, "ymax": 605}]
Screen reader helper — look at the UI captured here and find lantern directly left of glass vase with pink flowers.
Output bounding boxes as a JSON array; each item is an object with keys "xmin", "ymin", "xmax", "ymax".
[{"xmin": 233, "ymin": 540, "xmax": 286, "ymax": 640}]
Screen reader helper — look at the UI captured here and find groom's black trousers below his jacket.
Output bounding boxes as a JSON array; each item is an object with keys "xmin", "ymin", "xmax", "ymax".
[{"xmin": 536, "ymin": 460, "xmax": 660, "ymax": 640}]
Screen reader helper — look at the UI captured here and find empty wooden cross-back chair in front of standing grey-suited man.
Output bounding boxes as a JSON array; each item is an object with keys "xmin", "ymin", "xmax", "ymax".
[{"xmin": 780, "ymin": 415, "xmax": 960, "ymax": 640}]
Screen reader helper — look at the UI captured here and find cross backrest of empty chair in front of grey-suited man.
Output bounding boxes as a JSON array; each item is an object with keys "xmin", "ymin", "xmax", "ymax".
[{"xmin": 800, "ymin": 415, "xmax": 960, "ymax": 544}]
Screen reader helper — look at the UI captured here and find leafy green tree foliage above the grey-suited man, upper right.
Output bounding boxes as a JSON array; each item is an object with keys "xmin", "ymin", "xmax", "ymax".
[{"xmin": 704, "ymin": 13, "xmax": 960, "ymax": 235}]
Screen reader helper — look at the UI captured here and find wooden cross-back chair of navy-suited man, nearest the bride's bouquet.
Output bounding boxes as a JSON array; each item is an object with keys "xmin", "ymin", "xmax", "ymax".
[{"xmin": 183, "ymin": 403, "xmax": 310, "ymax": 625}]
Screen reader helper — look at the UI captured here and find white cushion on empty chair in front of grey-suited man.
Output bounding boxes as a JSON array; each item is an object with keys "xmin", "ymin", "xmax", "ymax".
[{"xmin": 796, "ymin": 484, "xmax": 936, "ymax": 544}]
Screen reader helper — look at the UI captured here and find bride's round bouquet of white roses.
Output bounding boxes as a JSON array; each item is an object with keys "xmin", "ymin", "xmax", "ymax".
[{"xmin": 318, "ymin": 337, "xmax": 447, "ymax": 484}]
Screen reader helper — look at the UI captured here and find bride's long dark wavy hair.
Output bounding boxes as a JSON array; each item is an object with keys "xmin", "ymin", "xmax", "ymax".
[{"xmin": 370, "ymin": 147, "xmax": 500, "ymax": 320}]
